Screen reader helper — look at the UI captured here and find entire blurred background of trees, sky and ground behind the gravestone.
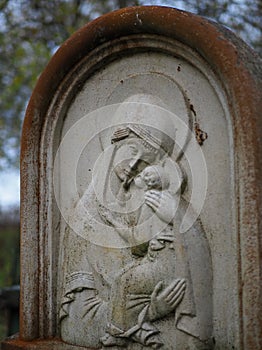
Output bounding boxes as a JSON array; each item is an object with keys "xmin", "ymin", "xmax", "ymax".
[{"xmin": 0, "ymin": 0, "xmax": 262, "ymax": 340}]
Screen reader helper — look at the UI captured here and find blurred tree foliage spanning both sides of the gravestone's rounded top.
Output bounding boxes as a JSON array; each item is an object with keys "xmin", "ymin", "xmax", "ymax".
[{"xmin": 0, "ymin": 0, "xmax": 262, "ymax": 170}]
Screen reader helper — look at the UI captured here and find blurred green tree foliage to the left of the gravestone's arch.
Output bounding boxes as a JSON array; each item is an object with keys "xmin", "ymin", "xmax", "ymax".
[{"xmin": 0, "ymin": 0, "xmax": 141, "ymax": 170}]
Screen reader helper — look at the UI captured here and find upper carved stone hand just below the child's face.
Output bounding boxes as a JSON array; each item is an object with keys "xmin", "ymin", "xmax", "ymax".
[{"xmin": 145, "ymin": 190, "xmax": 177, "ymax": 224}]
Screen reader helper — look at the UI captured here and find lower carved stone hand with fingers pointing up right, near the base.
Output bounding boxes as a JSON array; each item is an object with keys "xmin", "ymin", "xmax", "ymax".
[{"xmin": 148, "ymin": 279, "xmax": 186, "ymax": 321}]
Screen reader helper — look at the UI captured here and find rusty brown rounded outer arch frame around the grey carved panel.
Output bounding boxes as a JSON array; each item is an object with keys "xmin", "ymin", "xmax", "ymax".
[{"xmin": 14, "ymin": 6, "xmax": 262, "ymax": 349}]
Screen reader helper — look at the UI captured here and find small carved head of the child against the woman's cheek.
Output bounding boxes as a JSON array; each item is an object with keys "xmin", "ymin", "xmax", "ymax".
[{"xmin": 141, "ymin": 165, "xmax": 169, "ymax": 190}]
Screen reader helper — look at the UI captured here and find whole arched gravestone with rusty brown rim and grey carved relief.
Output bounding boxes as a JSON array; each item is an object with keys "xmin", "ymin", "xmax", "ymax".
[{"xmin": 2, "ymin": 6, "xmax": 262, "ymax": 350}]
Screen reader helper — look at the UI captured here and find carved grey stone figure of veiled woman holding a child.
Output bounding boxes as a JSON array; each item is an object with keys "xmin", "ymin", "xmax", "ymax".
[{"xmin": 60, "ymin": 95, "xmax": 212, "ymax": 350}]
